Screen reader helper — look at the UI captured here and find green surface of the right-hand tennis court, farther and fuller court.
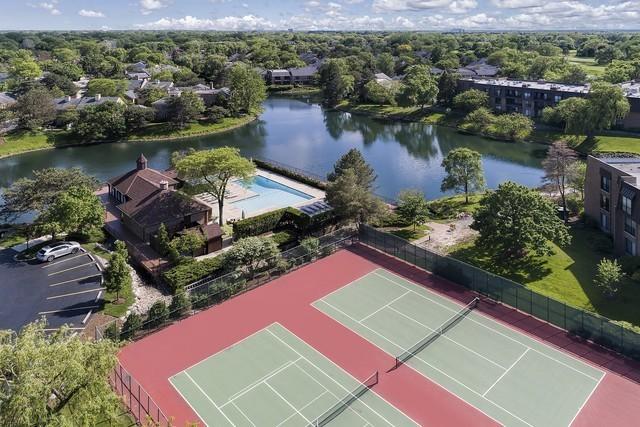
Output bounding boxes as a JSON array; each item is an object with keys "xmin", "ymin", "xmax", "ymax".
[{"xmin": 313, "ymin": 269, "xmax": 604, "ymax": 427}]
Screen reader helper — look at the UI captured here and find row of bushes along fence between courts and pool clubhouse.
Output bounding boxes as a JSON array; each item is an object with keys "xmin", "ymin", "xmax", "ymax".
[{"xmin": 95, "ymin": 228, "xmax": 357, "ymax": 340}]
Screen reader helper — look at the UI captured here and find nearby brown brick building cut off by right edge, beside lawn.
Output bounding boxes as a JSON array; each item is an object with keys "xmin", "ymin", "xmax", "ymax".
[{"xmin": 584, "ymin": 156, "xmax": 640, "ymax": 256}]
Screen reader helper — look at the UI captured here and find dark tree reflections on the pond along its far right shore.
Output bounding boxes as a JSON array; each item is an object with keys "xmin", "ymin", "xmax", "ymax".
[{"xmin": 323, "ymin": 111, "xmax": 546, "ymax": 168}]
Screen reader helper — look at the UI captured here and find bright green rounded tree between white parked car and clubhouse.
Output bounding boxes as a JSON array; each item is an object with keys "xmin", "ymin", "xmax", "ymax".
[{"xmin": 38, "ymin": 187, "xmax": 105, "ymax": 233}]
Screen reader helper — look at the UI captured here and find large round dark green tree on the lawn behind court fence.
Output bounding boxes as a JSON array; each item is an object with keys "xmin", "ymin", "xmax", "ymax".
[{"xmin": 471, "ymin": 181, "xmax": 571, "ymax": 260}]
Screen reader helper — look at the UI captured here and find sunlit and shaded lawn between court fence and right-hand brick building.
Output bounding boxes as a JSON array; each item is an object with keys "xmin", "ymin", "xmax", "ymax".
[{"xmin": 450, "ymin": 228, "xmax": 640, "ymax": 325}]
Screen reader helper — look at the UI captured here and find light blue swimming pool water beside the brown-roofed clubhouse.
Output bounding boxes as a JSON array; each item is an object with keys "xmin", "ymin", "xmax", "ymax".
[{"xmin": 232, "ymin": 176, "xmax": 313, "ymax": 214}]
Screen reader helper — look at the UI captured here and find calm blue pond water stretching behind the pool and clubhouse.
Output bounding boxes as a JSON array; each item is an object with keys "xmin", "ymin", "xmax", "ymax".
[{"xmin": 0, "ymin": 98, "xmax": 546, "ymax": 206}]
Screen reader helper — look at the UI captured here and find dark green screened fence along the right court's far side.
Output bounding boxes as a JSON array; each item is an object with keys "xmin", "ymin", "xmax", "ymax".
[{"xmin": 358, "ymin": 225, "xmax": 640, "ymax": 360}]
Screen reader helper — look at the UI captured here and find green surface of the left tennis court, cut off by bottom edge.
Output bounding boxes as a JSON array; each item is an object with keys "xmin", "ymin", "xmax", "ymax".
[{"xmin": 170, "ymin": 323, "xmax": 417, "ymax": 427}]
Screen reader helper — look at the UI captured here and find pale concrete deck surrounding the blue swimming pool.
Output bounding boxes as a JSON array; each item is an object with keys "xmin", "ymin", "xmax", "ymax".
[{"xmin": 196, "ymin": 169, "xmax": 325, "ymax": 221}]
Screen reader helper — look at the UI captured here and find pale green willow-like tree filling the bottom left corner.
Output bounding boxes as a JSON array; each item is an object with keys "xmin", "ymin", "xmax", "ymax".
[{"xmin": 0, "ymin": 321, "xmax": 121, "ymax": 426}]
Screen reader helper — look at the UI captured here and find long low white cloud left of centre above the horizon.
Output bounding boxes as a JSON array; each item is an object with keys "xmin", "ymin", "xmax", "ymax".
[{"xmin": 136, "ymin": 15, "xmax": 276, "ymax": 31}]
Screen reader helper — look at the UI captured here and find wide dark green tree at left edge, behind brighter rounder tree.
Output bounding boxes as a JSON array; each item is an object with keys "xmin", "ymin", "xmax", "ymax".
[{"xmin": 0, "ymin": 168, "xmax": 98, "ymax": 218}]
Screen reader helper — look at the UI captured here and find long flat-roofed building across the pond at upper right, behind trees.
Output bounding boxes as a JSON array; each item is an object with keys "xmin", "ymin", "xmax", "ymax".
[{"xmin": 458, "ymin": 77, "xmax": 640, "ymax": 129}]
